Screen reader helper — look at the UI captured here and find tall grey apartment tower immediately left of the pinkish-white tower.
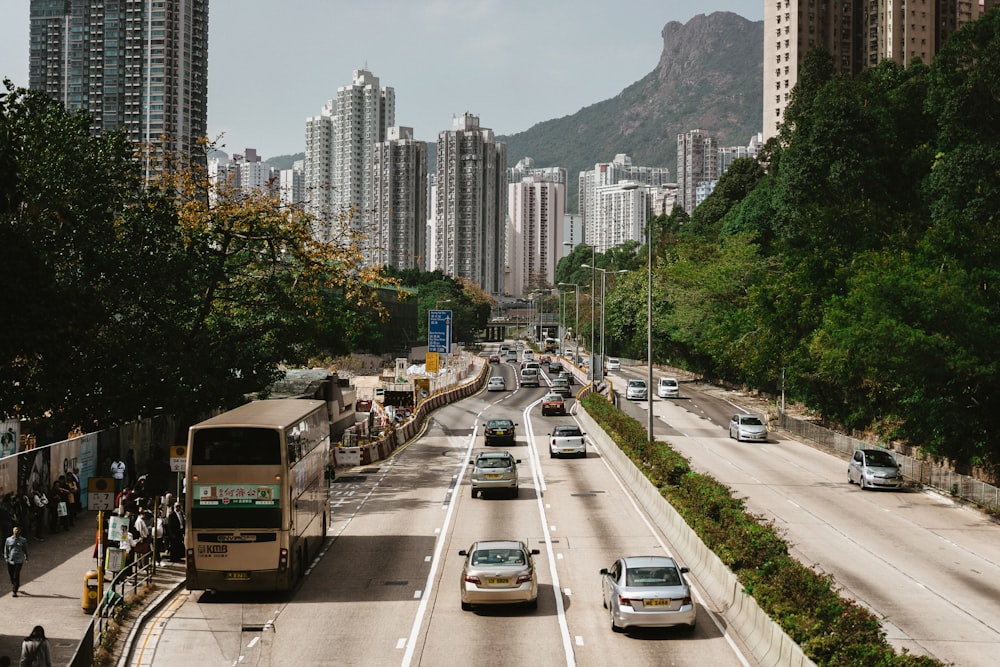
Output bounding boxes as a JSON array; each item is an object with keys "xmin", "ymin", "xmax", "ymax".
[{"xmin": 433, "ymin": 113, "xmax": 507, "ymax": 294}]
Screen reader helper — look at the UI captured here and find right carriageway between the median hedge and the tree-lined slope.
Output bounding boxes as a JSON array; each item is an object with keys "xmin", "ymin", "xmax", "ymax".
[{"xmin": 612, "ymin": 368, "xmax": 1000, "ymax": 667}]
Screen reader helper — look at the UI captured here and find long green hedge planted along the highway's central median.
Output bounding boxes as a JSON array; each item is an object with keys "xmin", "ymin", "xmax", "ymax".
[{"xmin": 582, "ymin": 394, "xmax": 940, "ymax": 667}]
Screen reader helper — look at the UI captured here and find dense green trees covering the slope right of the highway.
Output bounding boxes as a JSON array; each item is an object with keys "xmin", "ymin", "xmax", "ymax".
[{"xmin": 608, "ymin": 10, "xmax": 1000, "ymax": 468}]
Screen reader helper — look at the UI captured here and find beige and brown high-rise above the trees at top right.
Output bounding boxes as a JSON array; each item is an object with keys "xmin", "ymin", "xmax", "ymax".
[{"xmin": 763, "ymin": 0, "xmax": 997, "ymax": 141}]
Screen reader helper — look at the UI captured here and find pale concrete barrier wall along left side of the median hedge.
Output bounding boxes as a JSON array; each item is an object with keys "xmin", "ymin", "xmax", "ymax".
[{"xmin": 577, "ymin": 408, "xmax": 815, "ymax": 667}]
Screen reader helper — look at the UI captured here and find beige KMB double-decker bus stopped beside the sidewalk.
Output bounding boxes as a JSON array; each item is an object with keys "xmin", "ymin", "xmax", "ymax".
[{"xmin": 185, "ymin": 399, "xmax": 330, "ymax": 591}]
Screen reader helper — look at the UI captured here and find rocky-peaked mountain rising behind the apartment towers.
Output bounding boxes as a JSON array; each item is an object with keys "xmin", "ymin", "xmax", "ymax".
[{"xmin": 267, "ymin": 12, "xmax": 764, "ymax": 204}]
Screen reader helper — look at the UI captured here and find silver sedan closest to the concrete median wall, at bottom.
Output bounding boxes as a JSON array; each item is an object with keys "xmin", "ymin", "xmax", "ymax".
[{"xmin": 601, "ymin": 556, "xmax": 697, "ymax": 632}]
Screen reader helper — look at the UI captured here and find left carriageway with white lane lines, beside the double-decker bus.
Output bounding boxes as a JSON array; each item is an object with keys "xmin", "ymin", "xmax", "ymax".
[{"xmin": 137, "ymin": 364, "xmax": 753, "ymax": 667}]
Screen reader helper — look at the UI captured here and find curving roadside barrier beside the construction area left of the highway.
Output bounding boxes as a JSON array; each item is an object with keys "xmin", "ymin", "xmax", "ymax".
[{"xmin": 334, "ymin": 357, "xmax": 491, "ymax": 467}]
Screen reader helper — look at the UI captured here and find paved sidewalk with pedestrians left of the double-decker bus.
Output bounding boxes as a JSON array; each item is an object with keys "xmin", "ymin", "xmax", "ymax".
[{"xmin": 0, "ymin": 511, "xmax": 185, "ymax": 665}]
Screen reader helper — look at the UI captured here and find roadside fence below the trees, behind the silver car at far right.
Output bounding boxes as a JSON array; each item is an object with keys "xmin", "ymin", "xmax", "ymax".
[{"xmin": 778, "ymin": 414, "xmax": 1000, "ymax": 509}]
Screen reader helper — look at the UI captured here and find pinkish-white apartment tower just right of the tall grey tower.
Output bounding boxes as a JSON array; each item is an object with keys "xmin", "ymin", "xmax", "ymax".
[{"xmin": 504, "ymin": 176, "xmax": 566, "ymax": 295}]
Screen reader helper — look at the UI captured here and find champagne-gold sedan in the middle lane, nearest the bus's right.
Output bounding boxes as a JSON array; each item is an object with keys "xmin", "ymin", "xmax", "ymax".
[{"xmin": 458, "ymin": 540, "xmax": 539, "ymax": 611}]
